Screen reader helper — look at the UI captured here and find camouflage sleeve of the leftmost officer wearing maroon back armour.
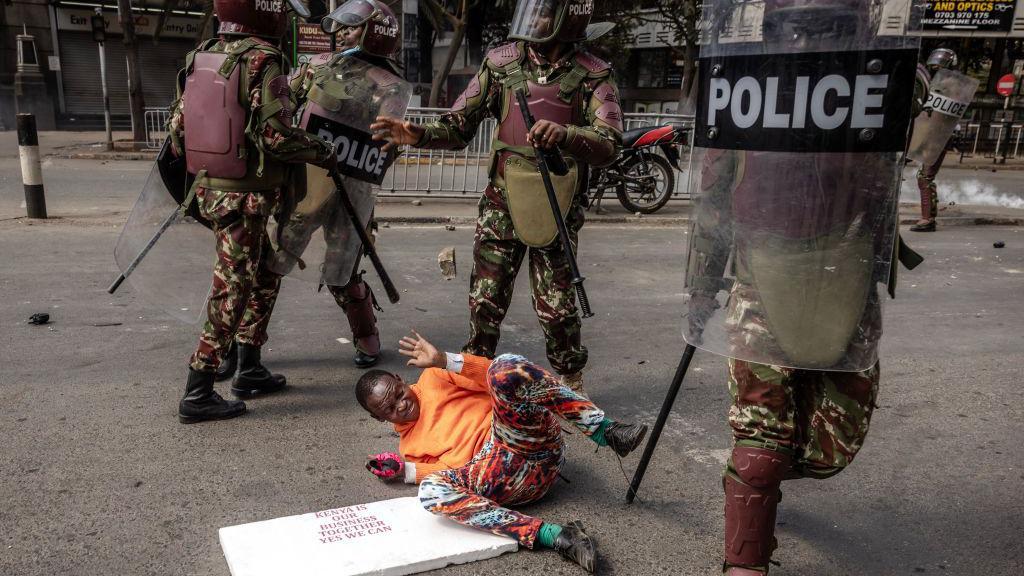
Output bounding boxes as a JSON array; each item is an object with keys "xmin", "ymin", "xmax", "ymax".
[{"xmin": 249, "ymin": 61, "xmax": 332, "ymax": 164}]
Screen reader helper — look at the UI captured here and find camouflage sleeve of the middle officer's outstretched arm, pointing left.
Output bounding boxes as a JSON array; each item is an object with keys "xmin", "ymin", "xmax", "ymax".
[{"xmin": 416, "ymin": 64, "xmax": 494, "ymax": 150}]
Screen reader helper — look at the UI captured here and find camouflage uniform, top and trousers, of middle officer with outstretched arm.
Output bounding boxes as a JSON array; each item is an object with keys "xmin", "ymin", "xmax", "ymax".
[{"xmin": 416, "ymin": 42, "xmax": 622, "ymax": 375}]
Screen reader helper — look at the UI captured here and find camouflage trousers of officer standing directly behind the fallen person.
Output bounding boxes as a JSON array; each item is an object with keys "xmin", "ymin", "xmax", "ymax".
[{"xmin": 463, "ymin": 187, "xmax": 587, "ymax": 374}]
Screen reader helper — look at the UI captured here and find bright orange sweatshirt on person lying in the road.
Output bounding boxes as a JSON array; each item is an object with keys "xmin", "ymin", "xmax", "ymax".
[{"xmin": 394, "ymin": 354, "xmax": 492, "ymax": 484}]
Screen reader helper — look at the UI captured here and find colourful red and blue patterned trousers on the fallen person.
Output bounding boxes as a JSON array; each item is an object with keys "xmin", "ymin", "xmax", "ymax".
[{"xmin": 420, "ymin": 355, "xmax": 604, "ymax": 548}]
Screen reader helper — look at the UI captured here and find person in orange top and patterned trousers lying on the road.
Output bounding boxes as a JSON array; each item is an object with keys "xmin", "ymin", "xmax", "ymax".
[{"xmin": 355, "ymin": 332, "xmax": 647, "ymax": 572}]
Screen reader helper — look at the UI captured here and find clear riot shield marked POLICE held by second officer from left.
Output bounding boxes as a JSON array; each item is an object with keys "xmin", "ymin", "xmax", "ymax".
[{"xmin": 270, "ymin": 54, "xmax": 412, "ymax": 286}]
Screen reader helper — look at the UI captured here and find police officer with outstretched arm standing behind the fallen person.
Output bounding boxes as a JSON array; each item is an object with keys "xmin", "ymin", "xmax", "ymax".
[{"xmin": 374, "ymin": 0, "xmax": 623, "ymax": 390}]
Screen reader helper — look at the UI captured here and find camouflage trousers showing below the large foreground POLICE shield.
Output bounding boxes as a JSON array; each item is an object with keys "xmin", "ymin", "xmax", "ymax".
[{"xmin": 729, "ymin": 359, "xmax": 880, "ymax": 479}]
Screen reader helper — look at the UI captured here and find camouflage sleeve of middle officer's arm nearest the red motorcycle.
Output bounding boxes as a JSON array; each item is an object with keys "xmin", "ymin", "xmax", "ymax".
[{"xmin": 560, "ymin": 75, "xmax": 623, "ymax": 167}]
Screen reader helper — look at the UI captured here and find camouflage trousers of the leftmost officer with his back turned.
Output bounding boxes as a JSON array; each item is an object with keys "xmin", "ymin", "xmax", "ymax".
[{"xmin": 190, "ymin": 188, "xmax": 281, "ymax": 371}]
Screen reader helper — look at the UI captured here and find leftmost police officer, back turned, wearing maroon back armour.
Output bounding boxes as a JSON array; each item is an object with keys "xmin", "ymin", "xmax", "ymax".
[{"xmin": 168, "ymin": 0, "xmax": 334, "ymax": 423}]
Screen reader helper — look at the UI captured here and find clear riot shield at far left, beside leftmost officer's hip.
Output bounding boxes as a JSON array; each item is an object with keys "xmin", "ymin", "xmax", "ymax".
[{"xmin": 114, "ymin": 163, "xmax": 217, "ymax": 323}]
